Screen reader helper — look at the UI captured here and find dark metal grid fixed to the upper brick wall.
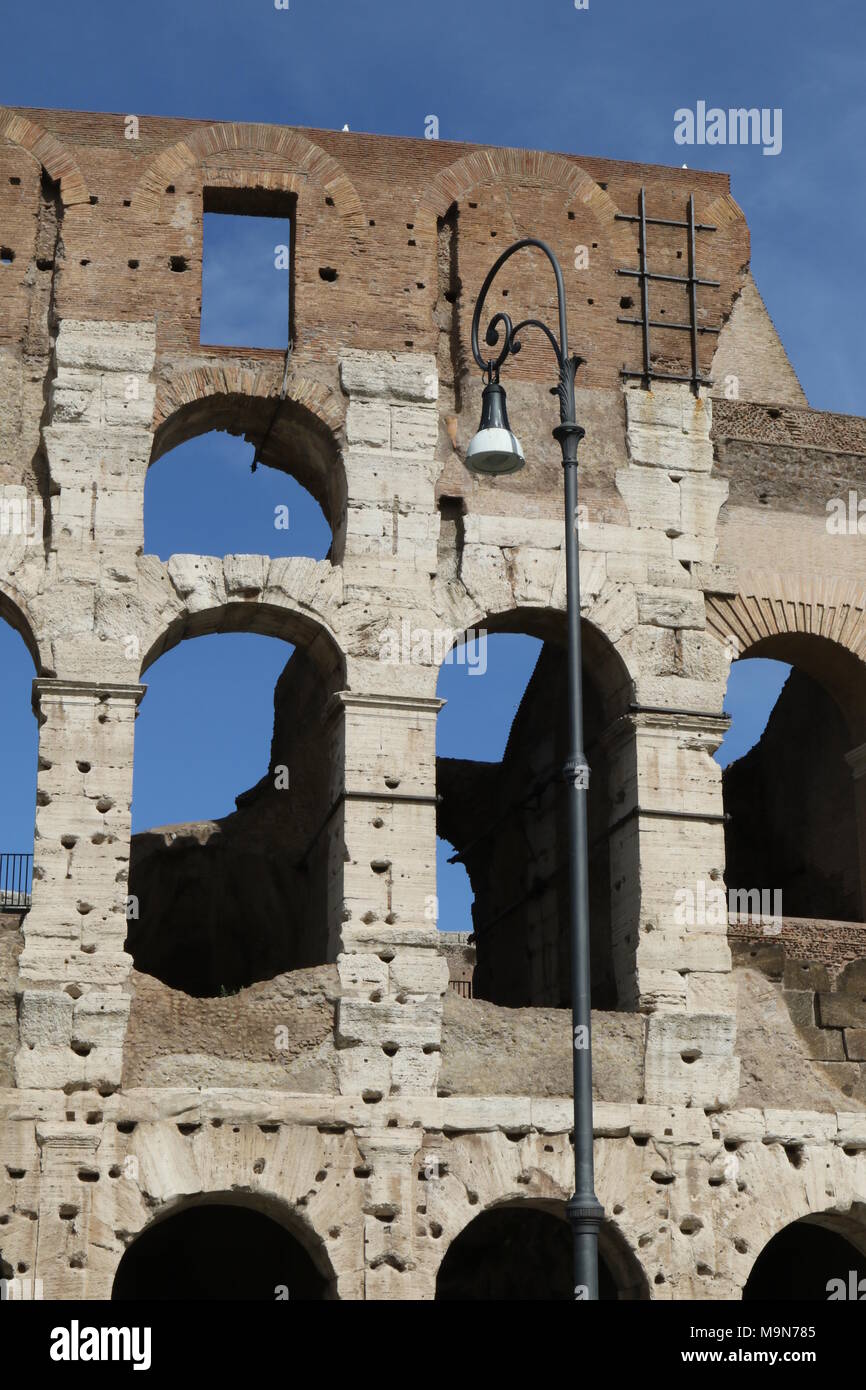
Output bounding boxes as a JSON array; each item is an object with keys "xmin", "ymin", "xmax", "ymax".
[{"xmin": 616, "ymin": 188, "xmax": 721, "ymax": 395}]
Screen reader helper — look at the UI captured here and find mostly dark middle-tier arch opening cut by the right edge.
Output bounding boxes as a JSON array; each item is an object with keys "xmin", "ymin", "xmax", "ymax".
[{"xmin": 719, "ymin": 632, "xmax": 866, "ymax": 923}]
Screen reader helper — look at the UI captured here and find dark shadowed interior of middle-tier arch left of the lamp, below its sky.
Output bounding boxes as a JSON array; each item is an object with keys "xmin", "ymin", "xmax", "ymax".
[{"xmin": 126, "ymin": 648, "xmax": 339, "ymax": 998}]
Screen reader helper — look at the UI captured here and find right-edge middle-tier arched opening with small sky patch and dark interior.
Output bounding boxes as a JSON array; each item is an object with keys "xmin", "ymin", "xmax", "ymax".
[{"xmin": 716, "ymin": 638, "xmax": 866, "ymax": 922}]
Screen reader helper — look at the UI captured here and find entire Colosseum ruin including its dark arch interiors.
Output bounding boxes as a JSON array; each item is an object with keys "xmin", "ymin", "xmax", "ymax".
[{"xmin": 0, "ymin": 108, "xmax": 866, "ymax": 1300}]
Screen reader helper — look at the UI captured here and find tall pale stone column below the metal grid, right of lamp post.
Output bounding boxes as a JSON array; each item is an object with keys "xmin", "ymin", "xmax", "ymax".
[{"xmin": 613, "ymin": 384, "xmax": 738, "ymax": 1108}]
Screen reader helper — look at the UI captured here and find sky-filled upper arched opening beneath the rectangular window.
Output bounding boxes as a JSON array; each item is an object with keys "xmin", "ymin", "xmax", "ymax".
[{"xmin": 145, "ymin": 430, "xmax": 331, "ymax": 560}]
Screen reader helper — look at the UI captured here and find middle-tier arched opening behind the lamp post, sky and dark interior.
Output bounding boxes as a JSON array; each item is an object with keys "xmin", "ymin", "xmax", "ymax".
[{"xmin": 436, "ymin": 616, "xmax": 631, "ymax": 1009}]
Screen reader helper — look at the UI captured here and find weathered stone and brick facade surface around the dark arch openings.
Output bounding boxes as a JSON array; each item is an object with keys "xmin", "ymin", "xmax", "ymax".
[{"xmin": 0, "ymin": 111, "xmax": 866, "ymax": 1300}]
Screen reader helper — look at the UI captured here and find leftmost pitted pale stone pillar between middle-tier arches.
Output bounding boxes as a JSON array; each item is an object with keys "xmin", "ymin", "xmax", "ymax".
[{"xmin": 15, "ymin": 680, "xmax": 145, "ymax": 1087}]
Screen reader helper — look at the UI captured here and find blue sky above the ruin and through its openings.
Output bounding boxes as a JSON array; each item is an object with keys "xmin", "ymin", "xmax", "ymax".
[{"xmin": 0, "ymin": 0, "xmax": 866, "ymax": 927}]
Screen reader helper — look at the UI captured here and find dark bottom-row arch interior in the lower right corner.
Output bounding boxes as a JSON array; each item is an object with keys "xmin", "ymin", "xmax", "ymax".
[{"xmin": 742, "ymin": 1220, "xmax": 866, "ymax": 1302}]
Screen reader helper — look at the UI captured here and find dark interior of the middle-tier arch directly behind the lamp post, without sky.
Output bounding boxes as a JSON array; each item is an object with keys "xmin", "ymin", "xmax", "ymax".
[{"xmin": 436, "ymin": 612, "xmax": 631, "ymax": 1009}]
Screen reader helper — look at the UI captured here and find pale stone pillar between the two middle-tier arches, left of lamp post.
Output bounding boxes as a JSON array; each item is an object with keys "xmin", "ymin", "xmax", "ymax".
[{"xmin": 329, "ymin": 691, "xmax": 448, "ymax": 1104}]
